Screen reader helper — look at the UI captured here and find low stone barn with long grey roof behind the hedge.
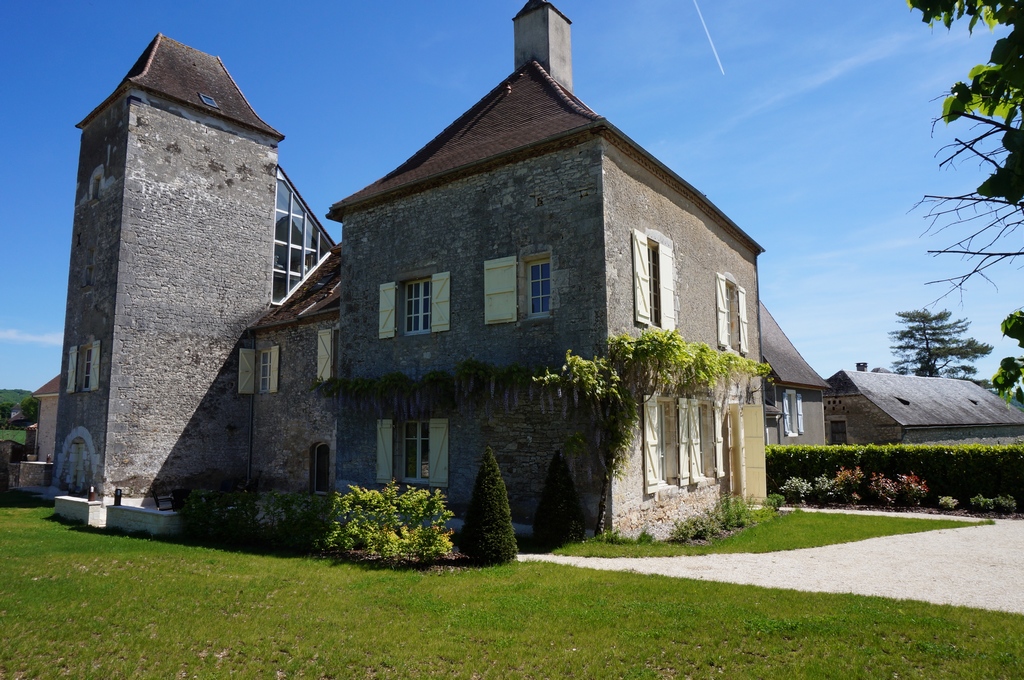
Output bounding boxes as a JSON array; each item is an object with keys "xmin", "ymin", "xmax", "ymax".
[{"xmin": 824, "ymin": 364, "xmax": 1024, "ymax": 444}]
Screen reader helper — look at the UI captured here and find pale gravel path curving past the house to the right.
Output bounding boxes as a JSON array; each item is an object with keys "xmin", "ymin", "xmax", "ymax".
[{"xmin": 519, "ymin": 514, "xmax": 1024, "ymax": 613}]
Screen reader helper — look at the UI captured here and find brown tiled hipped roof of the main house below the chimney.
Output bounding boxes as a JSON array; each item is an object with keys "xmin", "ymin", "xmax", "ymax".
[{"xmin": 329, "ymin": 61, "xmax": 602, "ymax": 218}]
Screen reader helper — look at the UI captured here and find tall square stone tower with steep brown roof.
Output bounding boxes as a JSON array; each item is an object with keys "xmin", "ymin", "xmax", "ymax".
[{"xmin": 54, "ymin": 35, "xmax": 284, "ymax": 496}]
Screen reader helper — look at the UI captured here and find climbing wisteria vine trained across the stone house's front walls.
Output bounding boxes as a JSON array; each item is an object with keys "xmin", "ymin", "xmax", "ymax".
[{"xmin": 316, "ymin": 329, "xmax": 769, "ymax": 532}]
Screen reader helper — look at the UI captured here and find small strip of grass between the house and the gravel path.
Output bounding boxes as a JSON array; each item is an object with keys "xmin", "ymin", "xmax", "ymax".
[{"xmin": 555, "ymin": 510, "xmax": 992, "ymax": 557}]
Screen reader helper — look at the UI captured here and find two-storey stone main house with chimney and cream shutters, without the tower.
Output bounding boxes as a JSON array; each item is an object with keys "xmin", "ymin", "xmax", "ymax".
[{"xmin": 328, "ymin": 0, "xmax": 764, "ymax": 533}]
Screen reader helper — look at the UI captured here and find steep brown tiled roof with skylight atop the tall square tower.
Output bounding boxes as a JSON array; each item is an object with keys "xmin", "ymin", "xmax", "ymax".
[{"xmin": 78, "ymin": 33, "xmax": 285, "ymax": 141}]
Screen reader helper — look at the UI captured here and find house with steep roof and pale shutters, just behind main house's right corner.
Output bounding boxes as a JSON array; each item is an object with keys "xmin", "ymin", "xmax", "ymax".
[{"xmin": 761, "ymin": 303, "xmax": 828, "ymax": 444}]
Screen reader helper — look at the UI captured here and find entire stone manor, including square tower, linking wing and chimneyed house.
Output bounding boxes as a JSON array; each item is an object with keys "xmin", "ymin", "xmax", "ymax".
[{"xmin": 53, "ymin": 0, "xmax": 765, "ymax": 534}]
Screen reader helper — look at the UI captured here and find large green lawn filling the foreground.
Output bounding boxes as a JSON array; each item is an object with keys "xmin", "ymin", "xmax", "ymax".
[{"xmin": 0, "ymin": 494, "xmax": 1024, "ymax": 679}]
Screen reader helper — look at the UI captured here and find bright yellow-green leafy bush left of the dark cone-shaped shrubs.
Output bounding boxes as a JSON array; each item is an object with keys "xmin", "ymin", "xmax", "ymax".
[{"xmin": 337, "ymin": 481, "xmax": 454, "ymax": 563}]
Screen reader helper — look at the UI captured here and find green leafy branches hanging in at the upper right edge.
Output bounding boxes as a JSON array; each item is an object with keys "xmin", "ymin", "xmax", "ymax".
[{"xmin": 907, "ymin": 0, "xmax": 1024, "ymax": 401}]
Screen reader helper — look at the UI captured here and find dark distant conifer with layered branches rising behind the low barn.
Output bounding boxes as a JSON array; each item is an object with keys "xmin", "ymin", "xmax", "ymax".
[{"xmin": 889, "ymin": 309, "xmax": 992, "ymax": 379}]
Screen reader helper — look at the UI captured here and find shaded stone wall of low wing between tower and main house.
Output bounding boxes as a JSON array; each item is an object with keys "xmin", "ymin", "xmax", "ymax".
[{"xmin": 252, "ymin": 312, "xmax": 335, "ymax": 492}]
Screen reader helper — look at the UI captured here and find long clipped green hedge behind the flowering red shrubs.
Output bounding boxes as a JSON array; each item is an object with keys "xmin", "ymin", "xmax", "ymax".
[{"xmin": 765, "ymin": 444, "xmax": 1024, "ymax": 507}]
